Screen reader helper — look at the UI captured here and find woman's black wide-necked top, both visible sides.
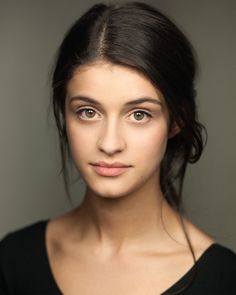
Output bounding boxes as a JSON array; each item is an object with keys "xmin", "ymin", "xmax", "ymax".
[{"xmin": 0, "ymin": 221, "xmax": 236, "ymax": 295}]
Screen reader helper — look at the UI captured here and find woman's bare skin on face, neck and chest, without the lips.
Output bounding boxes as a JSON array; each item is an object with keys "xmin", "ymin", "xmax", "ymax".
[{"xmin": 46, "ymin": 61, "xmax": 214, "ymax": 295}]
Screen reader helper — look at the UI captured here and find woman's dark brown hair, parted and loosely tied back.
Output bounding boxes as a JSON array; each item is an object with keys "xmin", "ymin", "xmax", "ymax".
[{"xmin": 52, "ymin": 2, "xmax": 203, "ymax": 209}]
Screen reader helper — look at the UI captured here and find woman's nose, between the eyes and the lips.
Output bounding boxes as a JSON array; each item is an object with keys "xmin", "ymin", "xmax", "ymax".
[{"xmin": 97, "ymin": 122, "xmax": 126, "ymax": 155}]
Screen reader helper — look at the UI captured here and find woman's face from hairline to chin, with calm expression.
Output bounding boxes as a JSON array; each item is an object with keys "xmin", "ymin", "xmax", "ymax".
[{"xmin": 65, "ymin": 62, "xmax": 169, "ymax": 198}]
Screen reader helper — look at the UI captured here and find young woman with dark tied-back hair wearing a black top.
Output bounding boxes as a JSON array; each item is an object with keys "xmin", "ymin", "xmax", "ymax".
[{"xmin": 0, "ymin": 2, "xmax": 236, "ymax": 295}]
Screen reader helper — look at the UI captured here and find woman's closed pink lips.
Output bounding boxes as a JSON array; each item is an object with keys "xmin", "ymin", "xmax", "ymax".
[{"xmin": 92, "ymin": 162, "xmax": 130, "ymax": 176}]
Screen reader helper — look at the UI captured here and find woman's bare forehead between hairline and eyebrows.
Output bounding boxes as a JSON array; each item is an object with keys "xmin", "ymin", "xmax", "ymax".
[{"xmin": 67, "ymin": 61, "xmax": 164, "ymax": 103}]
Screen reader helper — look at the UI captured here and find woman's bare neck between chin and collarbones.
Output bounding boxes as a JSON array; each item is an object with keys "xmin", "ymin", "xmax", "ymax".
[{"xmin": 73, "ymin": 184, "xmax": 183, "ymax": 253}]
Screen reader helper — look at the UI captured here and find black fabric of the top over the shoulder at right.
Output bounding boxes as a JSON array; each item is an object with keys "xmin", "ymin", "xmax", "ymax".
[{"xmin": 163, "ymin": 242, "xmax": 236, "ymax": 295}]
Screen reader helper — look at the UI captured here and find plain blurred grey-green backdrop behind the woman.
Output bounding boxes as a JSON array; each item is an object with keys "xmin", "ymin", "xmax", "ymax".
[{"xmin": 0, "ymin": 0, "xmax": 236, "ymax": 250}]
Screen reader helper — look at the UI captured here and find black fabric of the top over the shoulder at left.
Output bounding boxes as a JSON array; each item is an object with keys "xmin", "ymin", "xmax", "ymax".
[{"xmin": 0, "ymin": 220, "xmax": 58, "ymax": 294}]
